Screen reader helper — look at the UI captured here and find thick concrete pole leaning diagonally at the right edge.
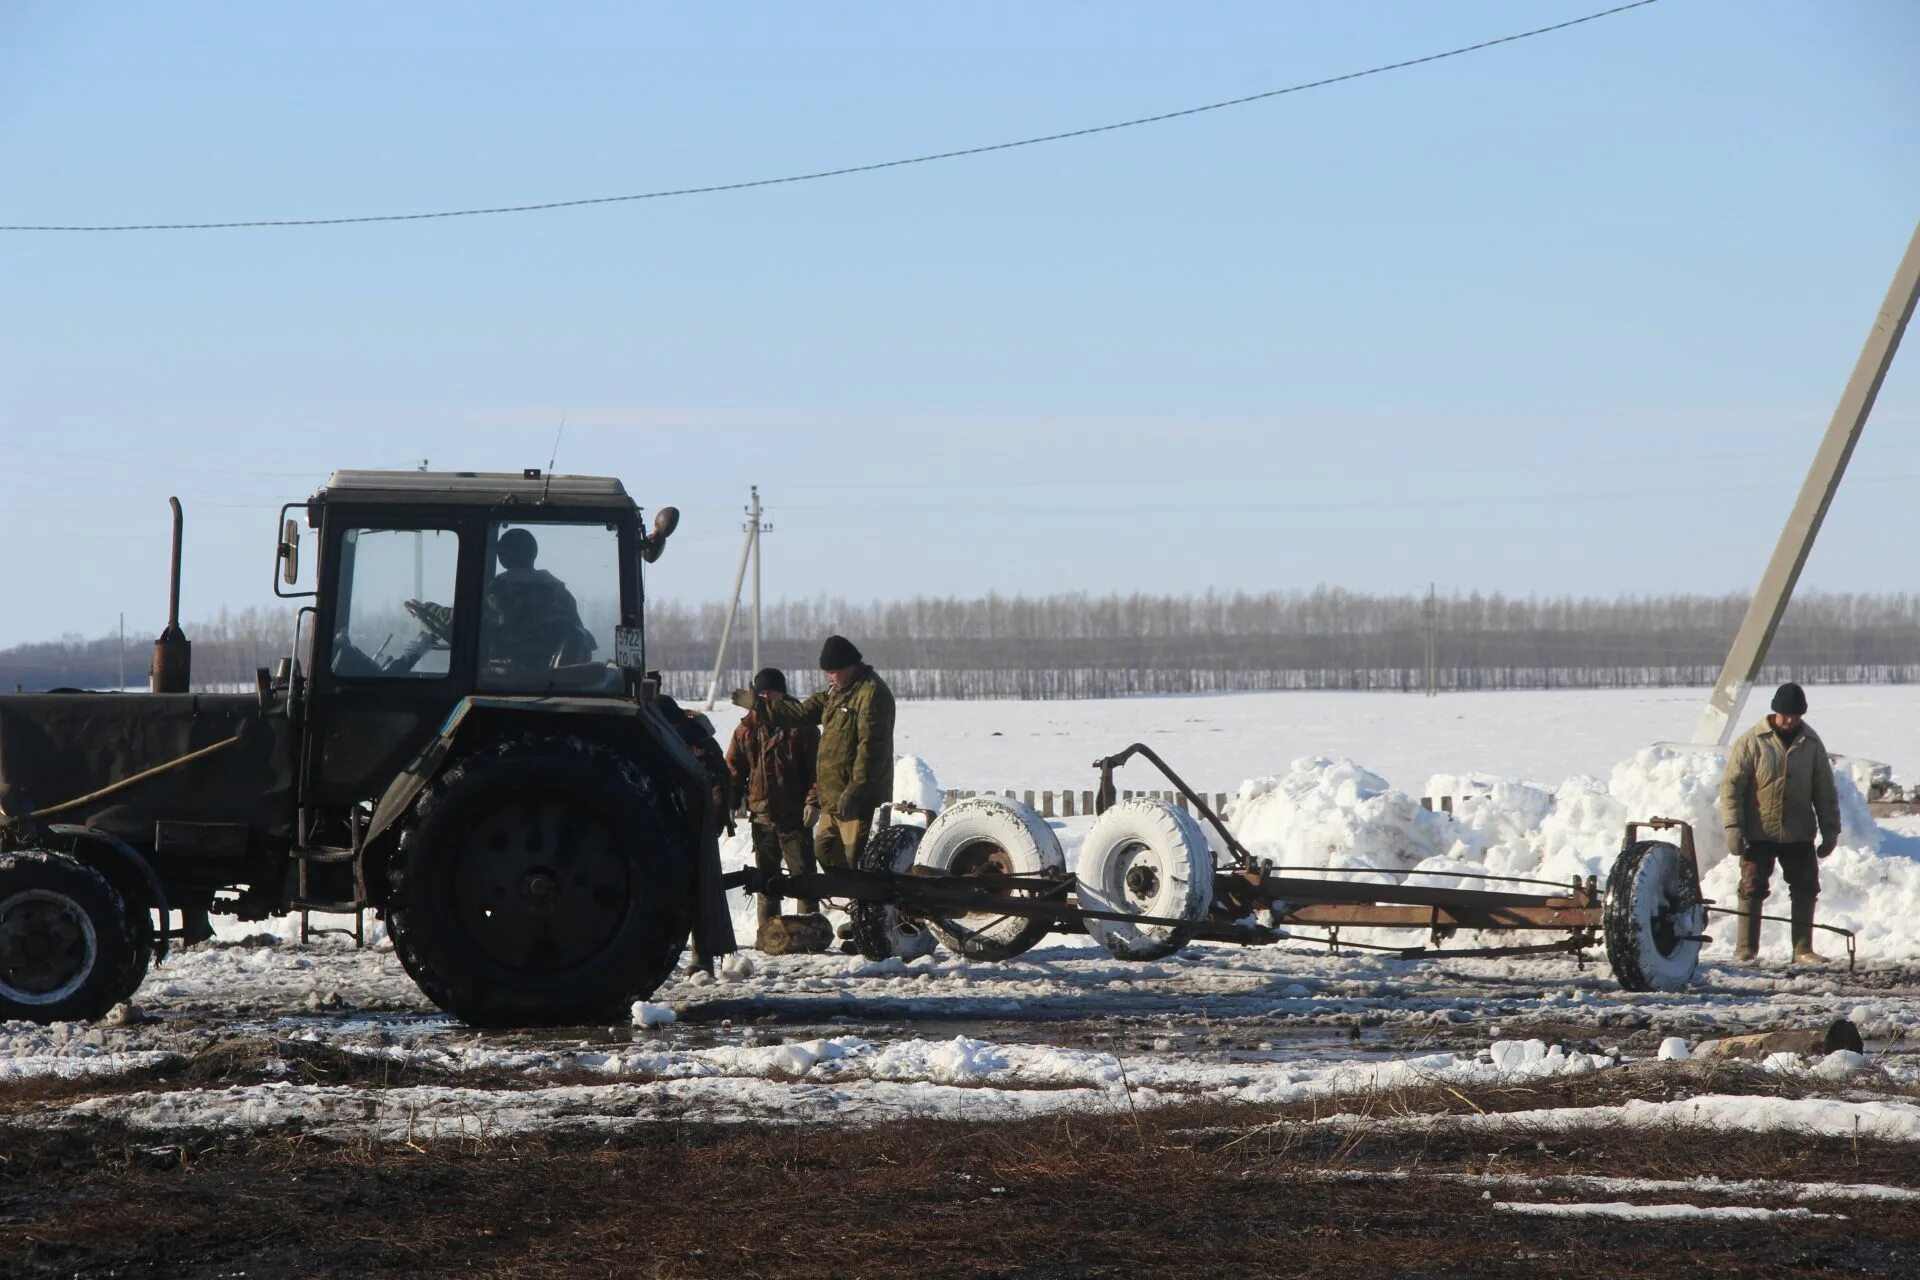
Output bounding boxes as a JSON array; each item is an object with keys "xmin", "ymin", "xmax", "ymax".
[{"xmin": 1693, "ymin": 225, "xmax": 1920, "ymax": 747}]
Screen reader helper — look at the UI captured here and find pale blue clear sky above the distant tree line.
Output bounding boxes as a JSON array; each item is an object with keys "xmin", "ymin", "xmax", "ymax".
[{"xmin": 0, "ymin": 0, "xmax": 1920, "ymax": 647}]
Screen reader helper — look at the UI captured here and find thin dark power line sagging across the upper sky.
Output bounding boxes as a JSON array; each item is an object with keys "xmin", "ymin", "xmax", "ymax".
[{"xmin": 0, "ymin": 0, "xmax": 1657, "ymax": 232}]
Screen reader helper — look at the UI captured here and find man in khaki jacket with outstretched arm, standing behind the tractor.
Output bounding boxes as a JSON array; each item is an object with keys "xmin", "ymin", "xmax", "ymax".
[{"xmin": 733, "ymin": 635, "xmax": 893, "ymax": 867}]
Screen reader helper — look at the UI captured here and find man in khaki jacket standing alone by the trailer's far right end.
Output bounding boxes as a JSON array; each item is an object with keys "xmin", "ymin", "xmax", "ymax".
[{"xmin": 1720, "ymin": 683, "xmax": 1839, "ymax": 963}]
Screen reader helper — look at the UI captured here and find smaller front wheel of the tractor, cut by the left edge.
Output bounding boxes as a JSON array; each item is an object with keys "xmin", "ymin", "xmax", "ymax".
[{"xmin": 0, "ymin": 850, "xmax": 134, "ymax": 1023}]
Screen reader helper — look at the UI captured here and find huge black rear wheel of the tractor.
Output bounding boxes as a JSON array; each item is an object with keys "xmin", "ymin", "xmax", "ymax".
[{"xmin": 388, "ymin": 737, "xmax": 695, "ymax": 1027}]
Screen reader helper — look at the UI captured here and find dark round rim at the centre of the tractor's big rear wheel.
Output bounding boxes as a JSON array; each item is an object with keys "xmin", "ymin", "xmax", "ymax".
[{"xmin": 451, "ymin": 796, "xmax": 634, "ymax": 973}]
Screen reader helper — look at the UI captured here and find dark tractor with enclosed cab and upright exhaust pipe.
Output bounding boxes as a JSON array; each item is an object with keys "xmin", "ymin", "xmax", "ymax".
[{"xmin": 0, "ymin": 470, "xmax": 733, "ymax": 1027}]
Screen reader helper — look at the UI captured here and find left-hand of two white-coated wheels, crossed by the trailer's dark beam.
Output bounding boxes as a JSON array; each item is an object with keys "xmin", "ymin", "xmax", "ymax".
[{"xmin": 916, "ymin": 796, "xmax": 1068, "ymax": 960}]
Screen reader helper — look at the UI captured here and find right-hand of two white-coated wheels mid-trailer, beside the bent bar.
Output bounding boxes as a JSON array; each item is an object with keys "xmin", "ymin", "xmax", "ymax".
[{"xmin": 1073, "ymin": 800, "xmax": 1213, "ymax": 960}]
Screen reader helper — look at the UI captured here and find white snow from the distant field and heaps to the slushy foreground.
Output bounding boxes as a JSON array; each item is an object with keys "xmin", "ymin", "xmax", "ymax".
[{"xmin": 0, "ymin": 689, "xmax": 1920, "ymax": 1144}]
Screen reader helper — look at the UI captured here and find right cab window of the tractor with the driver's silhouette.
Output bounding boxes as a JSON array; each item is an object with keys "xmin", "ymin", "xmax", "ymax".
[{"xmin": 478, "ymin": 520, "xmax": 626, "ymax": 693}]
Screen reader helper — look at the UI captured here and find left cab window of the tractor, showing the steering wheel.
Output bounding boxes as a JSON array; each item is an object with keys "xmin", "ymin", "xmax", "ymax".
[{"xmin": 332, "ymin": 528, "xmax": 461, "ymax": 679}]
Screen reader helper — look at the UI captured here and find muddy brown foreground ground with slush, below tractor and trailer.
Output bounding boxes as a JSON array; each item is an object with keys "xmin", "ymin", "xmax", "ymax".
[{"xmin": 0, "ymin": 944, "xmax": 1920, "ymax": 1278}]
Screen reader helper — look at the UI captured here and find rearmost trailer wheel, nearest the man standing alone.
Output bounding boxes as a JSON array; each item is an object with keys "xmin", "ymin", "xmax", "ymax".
[{"xmin": 1601, "ymin": 841, "xmax": 1707, "ymax": 990}]
